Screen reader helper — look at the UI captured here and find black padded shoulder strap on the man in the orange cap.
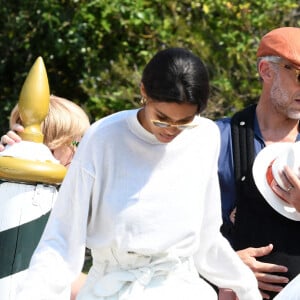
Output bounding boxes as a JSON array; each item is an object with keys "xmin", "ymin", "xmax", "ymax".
[{"xmin": 231, "ymin": 104, "xmax": 256, "ymax": 185}]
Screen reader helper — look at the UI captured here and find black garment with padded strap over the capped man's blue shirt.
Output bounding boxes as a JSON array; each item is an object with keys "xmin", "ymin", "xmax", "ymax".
[{"xmin": 231, "ymin": 105, "xmax": 300, "ymax": 297}]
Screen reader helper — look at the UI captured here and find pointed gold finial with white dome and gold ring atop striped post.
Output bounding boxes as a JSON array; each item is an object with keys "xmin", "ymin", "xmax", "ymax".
[{"xmin": 0, "ymin": 57, "xmax": 66, "ymax": 184}]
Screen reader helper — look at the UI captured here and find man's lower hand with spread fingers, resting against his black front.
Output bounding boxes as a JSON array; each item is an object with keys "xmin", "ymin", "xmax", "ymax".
[{"xmin": 237, "ymin": 244, "xmax": 289, "ymax": 299}]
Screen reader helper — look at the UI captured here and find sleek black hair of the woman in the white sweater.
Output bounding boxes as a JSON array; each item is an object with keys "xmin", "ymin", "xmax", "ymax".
[{"xmin": 142, "ymin": 48, "xmax": 209, "ymax": 113}]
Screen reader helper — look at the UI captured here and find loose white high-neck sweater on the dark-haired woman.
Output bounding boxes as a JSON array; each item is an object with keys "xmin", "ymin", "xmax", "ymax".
[{"xmin": 18, "ymin": 110, "xmax": 261, "ymax": 300}]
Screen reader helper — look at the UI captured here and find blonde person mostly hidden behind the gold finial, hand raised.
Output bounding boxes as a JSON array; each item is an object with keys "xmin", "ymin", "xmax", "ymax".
[{"xmin": 0, "ymin": 95, "xmax": 90, "ymax": 300}]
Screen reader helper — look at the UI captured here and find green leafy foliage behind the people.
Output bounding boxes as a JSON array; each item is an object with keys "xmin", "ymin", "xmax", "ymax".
[{"xmin": 0, "ymin": 0, "xmax": 300, "ymax": 132}]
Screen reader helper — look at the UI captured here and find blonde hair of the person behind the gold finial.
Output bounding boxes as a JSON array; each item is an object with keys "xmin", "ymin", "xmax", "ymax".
[{"xmin": 9, "ymin": 95, "xmax": 90, "ymax": 150}]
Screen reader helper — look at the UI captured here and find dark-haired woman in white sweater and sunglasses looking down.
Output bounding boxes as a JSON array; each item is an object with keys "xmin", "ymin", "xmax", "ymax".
[{"xmin": 17, "ymin": 48, "xmax": 261, "ymax": 300}]
